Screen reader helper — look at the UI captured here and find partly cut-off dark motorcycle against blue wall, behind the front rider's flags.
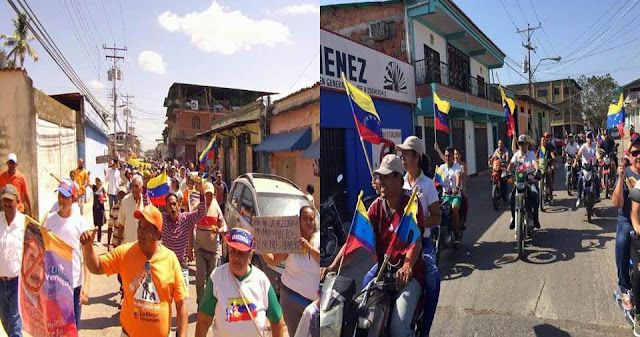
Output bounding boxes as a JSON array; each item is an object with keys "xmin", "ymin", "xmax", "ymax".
[{"xmin": 320, "ymin": 175, "xmax": 349, "ymax": 267}]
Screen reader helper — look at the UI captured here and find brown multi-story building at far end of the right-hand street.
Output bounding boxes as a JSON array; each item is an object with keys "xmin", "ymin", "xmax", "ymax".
[{"xmin": 509, "ymin": 78, "xmax": 584, "ymax": 136}]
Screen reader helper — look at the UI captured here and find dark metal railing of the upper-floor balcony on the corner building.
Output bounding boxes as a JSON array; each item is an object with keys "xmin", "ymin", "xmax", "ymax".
[{"xmin": 414, "ymin": 59, "xmax": 502, "ymax": 103}]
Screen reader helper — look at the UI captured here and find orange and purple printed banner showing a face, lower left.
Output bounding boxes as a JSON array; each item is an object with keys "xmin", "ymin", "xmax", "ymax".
[{"xmin": 19, "ymin": 216, "xmax": 78, "ymax": 337}]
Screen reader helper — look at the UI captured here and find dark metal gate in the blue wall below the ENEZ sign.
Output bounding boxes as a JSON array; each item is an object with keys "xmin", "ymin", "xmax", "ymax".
[{"xmin": 320, "ymin": 128, "xmax": 348, "ymax": 219}]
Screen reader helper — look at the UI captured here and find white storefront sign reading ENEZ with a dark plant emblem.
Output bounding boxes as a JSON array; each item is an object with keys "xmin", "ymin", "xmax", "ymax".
[{"xmin": 320, "ymin": 29, "xmax": 416, "ymax": 104}]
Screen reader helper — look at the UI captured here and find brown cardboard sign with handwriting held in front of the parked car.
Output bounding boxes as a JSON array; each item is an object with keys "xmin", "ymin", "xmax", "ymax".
[{"xmin": 251, "ymin": 216, "xmax": 302, "ymax": 254}]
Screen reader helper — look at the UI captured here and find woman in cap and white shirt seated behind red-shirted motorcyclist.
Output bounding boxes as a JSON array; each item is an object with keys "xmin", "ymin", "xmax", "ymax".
[{"xmin": 395, "ymin": 136, "xmax": 441, "ymax": 336}]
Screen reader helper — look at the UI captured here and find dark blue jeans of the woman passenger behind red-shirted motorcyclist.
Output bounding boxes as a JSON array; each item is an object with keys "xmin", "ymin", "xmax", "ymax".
[{"xmin": 422, "ymin": 238, "xmax": 442, "ymax": 336}]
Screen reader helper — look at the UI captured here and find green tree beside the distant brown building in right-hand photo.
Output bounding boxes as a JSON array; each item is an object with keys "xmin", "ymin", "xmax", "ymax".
[{"xmin": 578, "ymin": 74, "xmax": 619, "ymax": 129}]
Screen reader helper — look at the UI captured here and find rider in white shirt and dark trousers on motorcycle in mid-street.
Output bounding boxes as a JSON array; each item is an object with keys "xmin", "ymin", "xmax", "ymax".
[{"xmin": 507, "ymin": 134, "xmax": 540, "ymax": 229}]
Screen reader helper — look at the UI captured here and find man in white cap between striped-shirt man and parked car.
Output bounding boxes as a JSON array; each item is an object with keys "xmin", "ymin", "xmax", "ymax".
[{"xmin": 195, "ymin": 182, "xmax": 227, "ymax": 304}]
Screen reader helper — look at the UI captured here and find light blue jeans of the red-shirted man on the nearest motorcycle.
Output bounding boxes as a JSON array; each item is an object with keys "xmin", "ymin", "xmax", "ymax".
[{"xmin": 362, "ymin": 264, "xmax": 422, "ymax": 336}]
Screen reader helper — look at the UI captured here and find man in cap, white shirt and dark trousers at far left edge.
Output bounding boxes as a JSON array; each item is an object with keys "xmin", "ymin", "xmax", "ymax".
[{"xmin": 0, "ymin": 184, "xmax": 25, "ymax": 337}]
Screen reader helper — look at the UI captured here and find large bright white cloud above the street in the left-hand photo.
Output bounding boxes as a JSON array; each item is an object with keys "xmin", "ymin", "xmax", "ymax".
[{"xmin": 158, "ymin": 1, "xmax": 290, "ymax": 55}]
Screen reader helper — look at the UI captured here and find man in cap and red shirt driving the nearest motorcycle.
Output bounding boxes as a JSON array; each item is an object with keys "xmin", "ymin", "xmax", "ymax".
[{"xmin": 326, "ymin": 154, "xmax": 425, "ymax": 336}]
